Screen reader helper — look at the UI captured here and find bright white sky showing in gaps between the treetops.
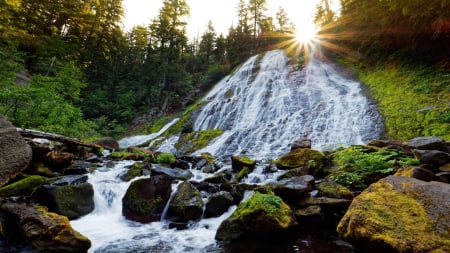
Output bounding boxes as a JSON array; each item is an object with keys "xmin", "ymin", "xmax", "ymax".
[{"xmin": 119, "ymin": 0, "xmax": 320, "ymax": 38}]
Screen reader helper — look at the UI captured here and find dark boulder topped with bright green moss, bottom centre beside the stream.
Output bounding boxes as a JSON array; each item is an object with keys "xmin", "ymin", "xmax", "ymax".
[{"xmin": 215, "ymin": 192, "xmax": 297, "ymax": 241}]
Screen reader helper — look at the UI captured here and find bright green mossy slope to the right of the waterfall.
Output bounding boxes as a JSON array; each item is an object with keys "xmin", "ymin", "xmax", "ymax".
[{"xmin": 353, "ymin": 59, "xmax": 450, "ymax": 139}]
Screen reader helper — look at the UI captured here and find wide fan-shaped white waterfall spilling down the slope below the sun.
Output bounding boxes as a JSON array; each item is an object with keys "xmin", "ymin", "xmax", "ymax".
[{"xmin": 194, "ymin": 50, "xmax": 382, "ymax": 159}]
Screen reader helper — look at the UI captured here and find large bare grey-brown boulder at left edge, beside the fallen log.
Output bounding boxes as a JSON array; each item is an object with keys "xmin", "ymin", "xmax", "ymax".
[{"xmin": 0, "ymin": 115, "xmax": 32, "ymax": 187}]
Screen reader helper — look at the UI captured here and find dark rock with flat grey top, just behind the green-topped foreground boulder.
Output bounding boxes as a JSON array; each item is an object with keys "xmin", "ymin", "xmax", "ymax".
[{"xmin": 271, "ymin": 175, "xmax": 314, "ymax": 204}]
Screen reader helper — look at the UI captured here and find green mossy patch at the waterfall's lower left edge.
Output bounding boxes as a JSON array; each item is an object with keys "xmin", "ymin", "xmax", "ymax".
[{"xmin": 175, "ymin": 129, "xmax": 223, "ymax": 154}]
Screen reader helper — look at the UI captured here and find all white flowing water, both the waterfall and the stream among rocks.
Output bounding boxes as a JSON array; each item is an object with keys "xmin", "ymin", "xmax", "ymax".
[{"xmin": 71, "ymin": 50, "xmax": 381, "ymax": 252}]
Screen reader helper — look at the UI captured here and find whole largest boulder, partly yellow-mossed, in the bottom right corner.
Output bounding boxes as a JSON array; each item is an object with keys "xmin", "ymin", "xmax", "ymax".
[{"xmin": 337, "ymin": 176, "xmax": 450, "ymax": 252}]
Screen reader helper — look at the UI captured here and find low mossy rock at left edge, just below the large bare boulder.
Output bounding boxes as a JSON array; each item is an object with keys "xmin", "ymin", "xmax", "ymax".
[{"xmin": 0, "ymin": 175, "xmax": 47, "ymax": 197}]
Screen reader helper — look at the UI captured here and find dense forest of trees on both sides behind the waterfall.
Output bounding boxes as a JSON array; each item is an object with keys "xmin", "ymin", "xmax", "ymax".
[{"xmin": 0, "ymin": 0, "xmax": 450, "ymax": 138}]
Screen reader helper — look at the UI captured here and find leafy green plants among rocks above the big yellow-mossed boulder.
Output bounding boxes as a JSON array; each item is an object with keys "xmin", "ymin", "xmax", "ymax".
[{"xmin": 328, "ymin": 146, "xmax": 419, "ymax": 190}]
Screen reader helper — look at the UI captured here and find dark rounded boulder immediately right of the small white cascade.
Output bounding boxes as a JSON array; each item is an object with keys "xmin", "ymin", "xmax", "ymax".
[{"xmin": 122, "ymin": 176, "xmax": 172, "ymax": 223}]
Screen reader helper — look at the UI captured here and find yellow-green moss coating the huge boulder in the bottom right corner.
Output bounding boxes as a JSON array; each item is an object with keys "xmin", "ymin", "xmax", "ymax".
[{"xmin": 337, "ymin": 181, "xmax": 450, "ymax": 252}]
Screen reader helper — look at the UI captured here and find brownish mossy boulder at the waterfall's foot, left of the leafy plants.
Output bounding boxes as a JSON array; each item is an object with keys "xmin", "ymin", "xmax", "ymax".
[{"xmin": 274, "ymin": 148, "xmax": 326, "ymax": 170}]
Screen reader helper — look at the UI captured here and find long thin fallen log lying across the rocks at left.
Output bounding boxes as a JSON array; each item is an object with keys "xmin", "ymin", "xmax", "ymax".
[{"xmin": 16, "ymin": 128, "xmax": 102, "ymax": 149}]
